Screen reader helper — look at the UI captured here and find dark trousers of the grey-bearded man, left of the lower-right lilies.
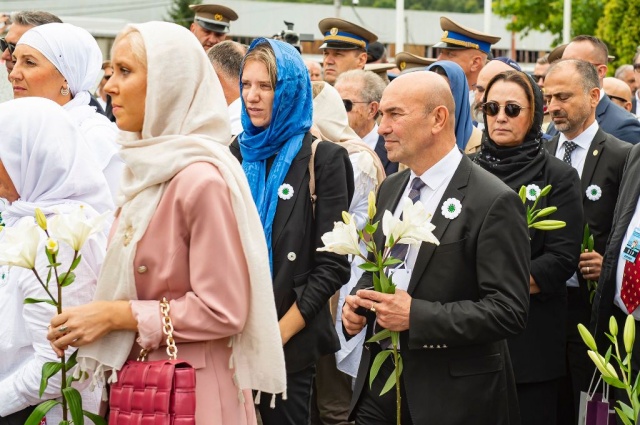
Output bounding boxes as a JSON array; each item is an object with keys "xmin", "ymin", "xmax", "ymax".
[{"xmin": 558, "ymin": 288, "xmax": 595, "ymax": 424}]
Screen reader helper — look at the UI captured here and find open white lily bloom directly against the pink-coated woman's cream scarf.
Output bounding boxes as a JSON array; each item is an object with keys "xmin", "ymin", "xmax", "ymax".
[{"xmin": 49, "ymin": 207, "xmax": 110, "ymax": 251}]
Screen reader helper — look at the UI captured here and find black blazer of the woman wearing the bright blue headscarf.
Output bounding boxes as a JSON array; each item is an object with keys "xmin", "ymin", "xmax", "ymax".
[{"xmin": 230, "ymin": 133, "xmax": 353, "ymax": 373}]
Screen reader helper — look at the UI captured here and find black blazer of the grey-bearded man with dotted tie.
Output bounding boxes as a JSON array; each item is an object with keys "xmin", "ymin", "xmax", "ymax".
[{"xmin": 546, "ymin": 128, "xmax": 633, "ymax": 304}]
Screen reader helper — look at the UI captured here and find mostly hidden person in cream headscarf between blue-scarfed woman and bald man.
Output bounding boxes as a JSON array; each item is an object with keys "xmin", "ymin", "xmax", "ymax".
[{"xmin": 311, "ymin": 81, "xmax": 385, "ymax": 422}]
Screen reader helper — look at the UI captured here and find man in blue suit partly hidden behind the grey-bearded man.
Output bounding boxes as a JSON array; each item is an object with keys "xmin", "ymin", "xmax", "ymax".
[{"xmin": 547, "ymin": 35, "xmax": 640, "ymax": 144}]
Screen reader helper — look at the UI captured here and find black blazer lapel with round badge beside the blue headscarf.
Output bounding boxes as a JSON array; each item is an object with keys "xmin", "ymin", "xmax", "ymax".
[{"xmin": 271, "ymin": 134, "xmax": 311, "ymax": 249}]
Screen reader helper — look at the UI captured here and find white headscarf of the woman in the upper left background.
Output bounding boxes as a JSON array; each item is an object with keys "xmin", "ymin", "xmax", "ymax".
[{"xmin": 18, "ymin": 22, "xmax": 102, "ymax": 109}]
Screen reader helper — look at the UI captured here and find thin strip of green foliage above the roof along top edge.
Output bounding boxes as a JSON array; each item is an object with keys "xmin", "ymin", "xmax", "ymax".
[{"xmin": 258, "ymin": 0, "xmax": 484, "ymax": 13}]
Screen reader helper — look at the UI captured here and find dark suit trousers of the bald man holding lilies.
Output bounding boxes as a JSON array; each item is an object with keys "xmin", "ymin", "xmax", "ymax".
[{"xmin": 355, "ymin": 352, "xmax": 413, "ymax": 425}]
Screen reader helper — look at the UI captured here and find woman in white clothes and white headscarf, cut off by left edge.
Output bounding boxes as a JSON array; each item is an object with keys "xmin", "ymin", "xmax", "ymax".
[{"xmin": 0, "ymin": 98, "xmax": 113, "ymax": 425}]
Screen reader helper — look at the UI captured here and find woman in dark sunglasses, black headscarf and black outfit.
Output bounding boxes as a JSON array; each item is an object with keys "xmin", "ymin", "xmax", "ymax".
[{"xmin": 474, "ymin": 71, "xmax": 582, "ymax": 425}]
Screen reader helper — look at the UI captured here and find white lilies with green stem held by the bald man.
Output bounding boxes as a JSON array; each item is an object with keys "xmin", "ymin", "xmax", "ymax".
[{"xmin": 318, "ymin": 192, "xmax": 438, "ymax": 424}]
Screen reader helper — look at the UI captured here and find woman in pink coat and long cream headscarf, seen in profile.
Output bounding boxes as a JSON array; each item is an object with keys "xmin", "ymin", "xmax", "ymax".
[{"xmin": 48, "ymin": 22, "xmax": 286, "ymax": 425}]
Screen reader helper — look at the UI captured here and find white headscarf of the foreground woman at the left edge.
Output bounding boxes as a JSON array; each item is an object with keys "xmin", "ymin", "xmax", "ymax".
[{"xmin": 0, "ymin": 97, "xmax": 113, "ymax": 225}]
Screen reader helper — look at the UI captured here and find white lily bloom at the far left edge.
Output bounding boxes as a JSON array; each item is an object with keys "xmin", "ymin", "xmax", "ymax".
[{"xmin": 0, "ymin": 220, "xmax": 40, "ymax": 269}]
